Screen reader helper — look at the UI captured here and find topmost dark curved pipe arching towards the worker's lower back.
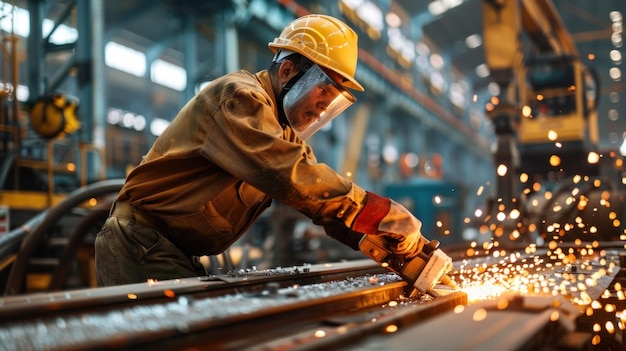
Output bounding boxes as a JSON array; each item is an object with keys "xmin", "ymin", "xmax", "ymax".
[{"xmin": 5, "ymin": 179, "xmax": 124, "ymax": 295}]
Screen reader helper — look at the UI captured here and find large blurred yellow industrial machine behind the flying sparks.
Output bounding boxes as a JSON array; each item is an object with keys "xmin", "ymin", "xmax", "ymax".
[{"xmin": 482, "ymin": 0, "xmax": 625, "ymax": 242}]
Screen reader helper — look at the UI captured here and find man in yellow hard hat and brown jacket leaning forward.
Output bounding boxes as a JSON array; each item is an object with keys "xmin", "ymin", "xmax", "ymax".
[{"xmin": 95, "ymin": 15, "xmax": 434, "ymax": 286}]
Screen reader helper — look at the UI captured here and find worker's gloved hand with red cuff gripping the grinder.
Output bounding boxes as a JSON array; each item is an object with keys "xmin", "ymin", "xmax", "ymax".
[{"xmin": 352, "ymin": 192, "xmax": 423, "ymax": 258}]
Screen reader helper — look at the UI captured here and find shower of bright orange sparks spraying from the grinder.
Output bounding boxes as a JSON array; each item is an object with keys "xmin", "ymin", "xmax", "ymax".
[{"xmin": 451, "ymin": 172, "xmax": 626, "ymax": 345}]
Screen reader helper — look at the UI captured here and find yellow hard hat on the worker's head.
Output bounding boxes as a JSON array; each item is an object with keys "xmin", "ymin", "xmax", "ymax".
[{"xmin": 268, "ymin": 15, "xmax": 365, "ymax": 91}]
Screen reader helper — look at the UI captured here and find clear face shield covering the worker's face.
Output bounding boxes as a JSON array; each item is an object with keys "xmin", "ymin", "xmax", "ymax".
[{"xmin": 283, "ymin": 65, "xmax": 356, "ymax": 139}]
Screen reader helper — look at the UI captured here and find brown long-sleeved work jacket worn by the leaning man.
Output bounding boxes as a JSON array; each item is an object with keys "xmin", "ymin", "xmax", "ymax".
[{"xmin": 118, "ymin": 70, "xmax": 366, "ymax": 255}]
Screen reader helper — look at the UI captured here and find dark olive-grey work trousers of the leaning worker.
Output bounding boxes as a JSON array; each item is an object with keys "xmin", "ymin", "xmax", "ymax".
[{"xmin": 95, "ymin": 217, "xmax": 205, "ymax": 286}]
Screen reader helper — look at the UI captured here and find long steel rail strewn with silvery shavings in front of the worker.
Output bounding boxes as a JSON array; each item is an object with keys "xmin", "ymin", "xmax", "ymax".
[{"xmin": 0, "ymin": 260, "xmax": 467, "ymax": 350}]
